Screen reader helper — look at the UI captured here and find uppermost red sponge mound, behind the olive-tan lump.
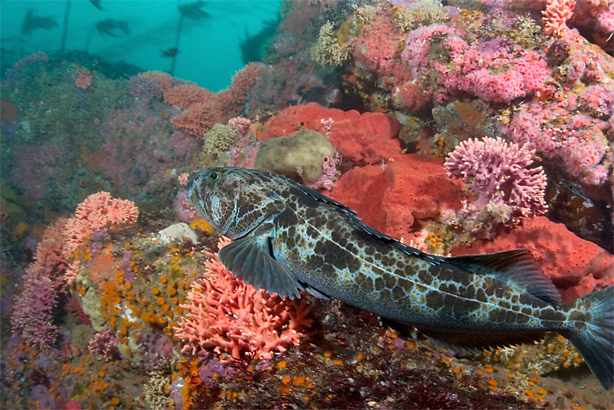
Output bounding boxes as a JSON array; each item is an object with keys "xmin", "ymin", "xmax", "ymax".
[{"xmin": 261, "ymin": 103, "xmax": 401, "ymax": 165}]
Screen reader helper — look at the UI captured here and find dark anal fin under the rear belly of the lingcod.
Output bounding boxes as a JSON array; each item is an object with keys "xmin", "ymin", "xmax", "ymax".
[{"xmin": 418, "ymin": 328, "xmax": 545, "ymax": 354}]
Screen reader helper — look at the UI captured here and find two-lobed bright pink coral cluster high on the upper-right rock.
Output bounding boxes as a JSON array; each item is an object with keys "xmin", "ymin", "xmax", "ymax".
[{"xmin": 401, "ymin": 24, "xmax": 551, "ymax": 103}]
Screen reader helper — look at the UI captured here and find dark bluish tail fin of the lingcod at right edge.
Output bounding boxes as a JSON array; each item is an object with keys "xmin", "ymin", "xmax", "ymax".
[{"xmin": 564, "ymin": 286, "xmax": 614, "ymax": 390}]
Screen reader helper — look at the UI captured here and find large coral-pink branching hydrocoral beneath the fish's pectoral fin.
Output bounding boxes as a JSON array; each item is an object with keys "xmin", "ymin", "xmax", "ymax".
[{"xmin": 174, "ymin": 238, "xmax": 312, "ymax": 359}]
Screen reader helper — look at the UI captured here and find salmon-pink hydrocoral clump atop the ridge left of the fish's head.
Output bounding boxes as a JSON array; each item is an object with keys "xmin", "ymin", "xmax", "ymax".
[{"xmin": 63, "ymin": 192, "xmax": 139, "ymax": 257}]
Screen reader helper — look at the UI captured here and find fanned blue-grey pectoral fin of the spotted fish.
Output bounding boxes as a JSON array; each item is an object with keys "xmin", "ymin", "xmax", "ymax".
[{"xmin": 218, "ymin": 236, "xmax": 304, "ymax": 299}]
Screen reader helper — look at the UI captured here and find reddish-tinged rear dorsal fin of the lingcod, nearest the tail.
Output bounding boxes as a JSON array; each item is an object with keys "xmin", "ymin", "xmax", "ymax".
[{"xmin": 445, "ymin": 249, "xmax": 563, "ymax": 308}]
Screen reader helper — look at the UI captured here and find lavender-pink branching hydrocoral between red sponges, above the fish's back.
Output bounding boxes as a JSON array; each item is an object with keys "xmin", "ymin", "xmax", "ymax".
[{"xmin": 444, "ymin": 137, "xmax": 548, "ymax": 216}]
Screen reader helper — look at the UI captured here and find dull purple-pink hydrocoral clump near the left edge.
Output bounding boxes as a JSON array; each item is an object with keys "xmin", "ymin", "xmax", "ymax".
[{"xmin": 11, "ymin": 267, "xmax": 58, "ymax": 350}]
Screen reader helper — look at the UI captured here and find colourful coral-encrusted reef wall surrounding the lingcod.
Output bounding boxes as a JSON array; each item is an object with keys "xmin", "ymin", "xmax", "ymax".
[{"xmin": 0, "ymin": 0, "xmax": 614, "ymax": 409}]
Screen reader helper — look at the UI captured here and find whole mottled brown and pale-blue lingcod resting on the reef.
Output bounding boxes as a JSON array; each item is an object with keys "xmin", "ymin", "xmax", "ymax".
[{"xmin": 187, "ymin": 168, "xmax": 614, "ymax": 390}]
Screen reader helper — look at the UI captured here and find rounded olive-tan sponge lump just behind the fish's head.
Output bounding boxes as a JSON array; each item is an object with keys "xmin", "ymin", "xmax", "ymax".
[{"xmin": 255, "ymin": 129, "xmax": 335, "ymax": 181}]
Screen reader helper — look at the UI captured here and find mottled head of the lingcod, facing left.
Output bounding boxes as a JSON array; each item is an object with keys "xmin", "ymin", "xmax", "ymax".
[{"xmin": 187, "ymin": 167, "xmax": 286, "ymax": 239}]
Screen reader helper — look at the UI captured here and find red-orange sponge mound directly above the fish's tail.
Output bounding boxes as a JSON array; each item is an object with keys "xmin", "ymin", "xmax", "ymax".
[{"xmin": 452, "ymin": 216, "xmax": 614, "ymax": 303}]
